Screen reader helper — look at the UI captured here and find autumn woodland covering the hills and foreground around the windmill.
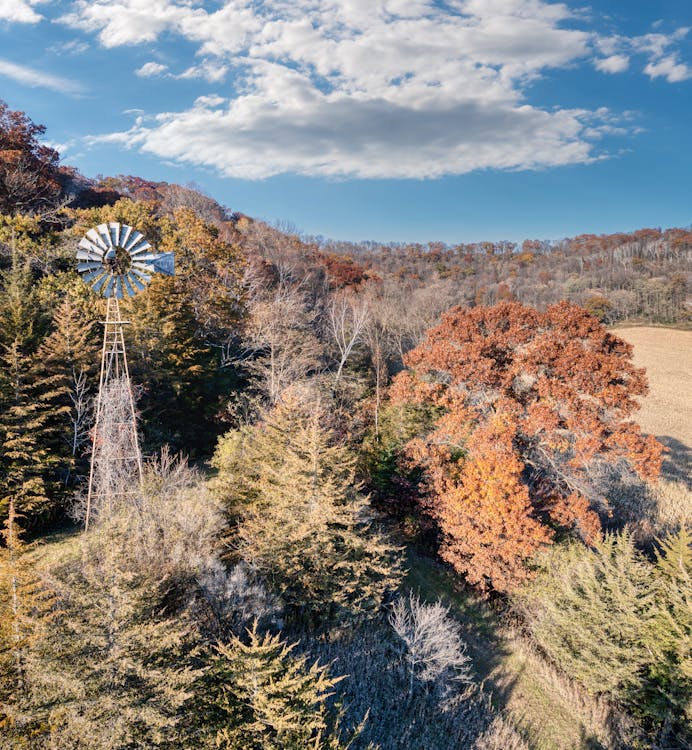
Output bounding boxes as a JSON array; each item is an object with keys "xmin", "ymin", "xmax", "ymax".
[{"xmin": 0, "ymin": 105, "xmax": 692, "ymax": 750}]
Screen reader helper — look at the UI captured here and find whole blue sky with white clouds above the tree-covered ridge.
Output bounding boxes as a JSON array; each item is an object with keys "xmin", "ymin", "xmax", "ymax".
[{"xmin": 0, "ymin": 0, "xmax": 692, "ymax": 243}]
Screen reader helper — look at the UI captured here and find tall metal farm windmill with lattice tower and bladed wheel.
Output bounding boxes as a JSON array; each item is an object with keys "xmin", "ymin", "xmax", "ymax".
[{"xmin": 77, "ymin": 221, "xmax": 175, "ymax": 529}]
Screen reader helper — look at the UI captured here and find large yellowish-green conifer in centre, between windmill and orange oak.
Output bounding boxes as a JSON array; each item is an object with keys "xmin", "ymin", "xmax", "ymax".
[{"xmin": 215, "ymin": 392, "xmax": 401, "ymax": 622}]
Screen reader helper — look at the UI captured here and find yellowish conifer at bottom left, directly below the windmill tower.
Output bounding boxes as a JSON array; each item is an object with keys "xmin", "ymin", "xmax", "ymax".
[{"xmin": 46, "ymin": 520, "xmax": 197, "ymax": 750}]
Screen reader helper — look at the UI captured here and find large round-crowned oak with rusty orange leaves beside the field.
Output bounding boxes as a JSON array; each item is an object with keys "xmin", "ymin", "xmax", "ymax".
[{"xmin": 391, "ymin": 302, "xmax": 662, "ymax": 591}]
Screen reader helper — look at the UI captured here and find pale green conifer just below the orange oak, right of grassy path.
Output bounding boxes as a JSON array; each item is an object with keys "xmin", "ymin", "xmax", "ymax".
[{"xmin": 517, "ymin": 532, "xmax": 654, "ymax": 699}]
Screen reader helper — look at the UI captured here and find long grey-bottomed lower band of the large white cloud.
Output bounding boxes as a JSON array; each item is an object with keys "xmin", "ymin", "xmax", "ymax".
[{"xmin": 98, "ymin": 89, "xmax": 612, "ymax": 179}]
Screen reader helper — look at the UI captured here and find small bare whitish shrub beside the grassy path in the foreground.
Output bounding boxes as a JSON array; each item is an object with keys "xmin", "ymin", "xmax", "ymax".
[{"xmin": 389, "ymin": 592, "xmax": 472, "ymax": 697}]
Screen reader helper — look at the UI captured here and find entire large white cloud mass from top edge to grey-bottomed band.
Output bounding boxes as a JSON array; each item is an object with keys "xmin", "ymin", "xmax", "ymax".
[{"xmin": 62, "ymin": 0, "xmax": 681, "ymax": 178}]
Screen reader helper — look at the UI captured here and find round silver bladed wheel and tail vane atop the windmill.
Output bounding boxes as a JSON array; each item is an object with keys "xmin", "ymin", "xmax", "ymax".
[{"xmin": 77, "ymin": 221, "xmax": 175, "ymax": 298}]
